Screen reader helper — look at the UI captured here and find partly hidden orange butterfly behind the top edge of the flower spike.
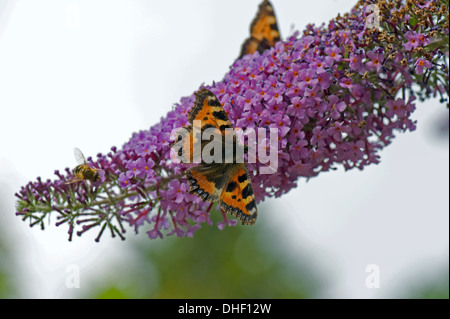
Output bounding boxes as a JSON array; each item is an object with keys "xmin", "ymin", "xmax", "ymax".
[{"xmin": 239, "ymin": 0, "xmax": 281, "ymax": 59}]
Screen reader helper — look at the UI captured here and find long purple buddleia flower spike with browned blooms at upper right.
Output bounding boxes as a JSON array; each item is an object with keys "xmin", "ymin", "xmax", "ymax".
[{"xmin": 17, "ymin": 1, "xmax": 448, "ymax": 238}]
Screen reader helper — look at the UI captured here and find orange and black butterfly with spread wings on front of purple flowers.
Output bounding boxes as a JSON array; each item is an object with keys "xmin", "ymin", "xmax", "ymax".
[{"xmin": 172, "ymin": 89, "xmax": 257, "ymax": 225}]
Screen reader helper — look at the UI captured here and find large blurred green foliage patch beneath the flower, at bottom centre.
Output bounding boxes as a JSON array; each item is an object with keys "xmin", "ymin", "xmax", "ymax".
[{"xmin": 90, "ymin": 210, "xmax": 319, "ymax": 299}]
